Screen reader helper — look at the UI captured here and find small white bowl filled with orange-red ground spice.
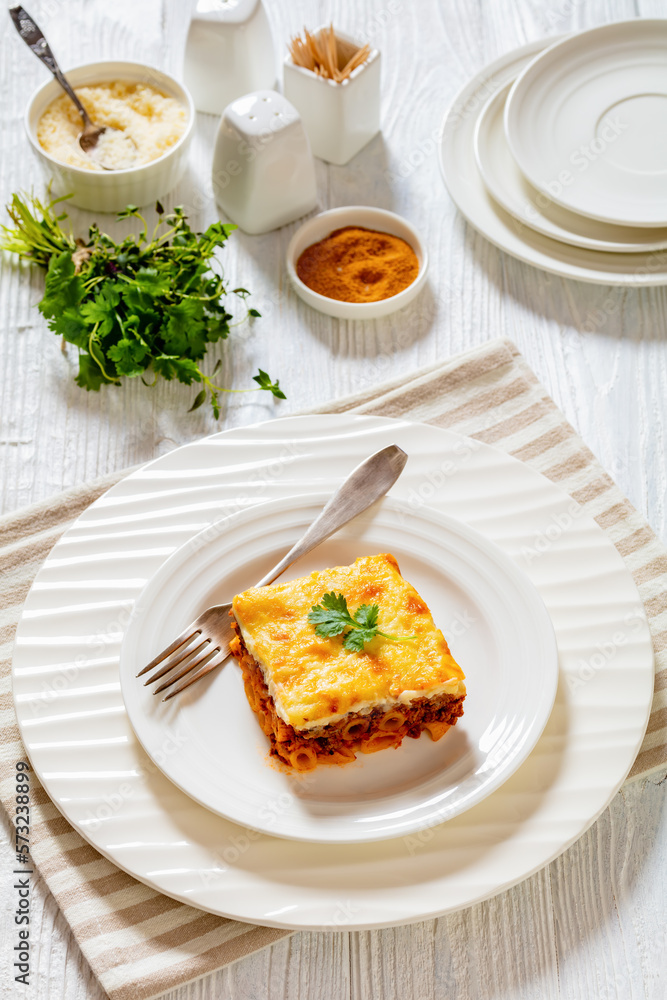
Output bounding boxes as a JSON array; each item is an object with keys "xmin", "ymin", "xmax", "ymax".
[{"xmin": 287, "ymin": 205, "xmax": 428, "ymax": 319}]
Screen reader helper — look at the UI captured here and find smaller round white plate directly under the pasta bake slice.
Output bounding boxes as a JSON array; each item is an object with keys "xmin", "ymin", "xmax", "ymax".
[{"xmin": 120, "ymin": 494, "xmax": 558, "ymax": 844}]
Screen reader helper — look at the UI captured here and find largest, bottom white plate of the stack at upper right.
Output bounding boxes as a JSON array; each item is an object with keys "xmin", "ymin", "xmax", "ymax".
[{"xmin": 440, "ymin": 39, "xmax": 667, "ymax": 287}]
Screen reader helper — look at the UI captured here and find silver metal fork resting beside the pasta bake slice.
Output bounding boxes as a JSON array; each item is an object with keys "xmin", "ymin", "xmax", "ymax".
[{"xmin": 137, "ymin": 444, "xmax": 408, "ymax": 701}]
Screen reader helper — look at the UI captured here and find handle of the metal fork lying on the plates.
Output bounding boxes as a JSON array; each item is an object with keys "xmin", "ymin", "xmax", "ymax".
[{"xmin": 257, "ymin": 444, "xmax": 408, "ymax": 587}]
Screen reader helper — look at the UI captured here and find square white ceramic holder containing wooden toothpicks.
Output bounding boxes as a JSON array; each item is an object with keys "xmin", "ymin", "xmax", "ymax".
[{"xmin": 283, "ymin": 28, "xmax": 380, "ymax": 166}]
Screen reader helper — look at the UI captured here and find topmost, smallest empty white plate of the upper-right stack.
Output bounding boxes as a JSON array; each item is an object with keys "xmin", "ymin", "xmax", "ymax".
[{"xmin": 505, "ymin": 18, "xmax": 667, "ymax": 227}]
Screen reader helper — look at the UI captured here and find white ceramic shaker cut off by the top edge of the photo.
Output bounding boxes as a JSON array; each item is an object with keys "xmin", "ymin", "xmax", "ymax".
[{"xmin": 183, "ymin": 0, "xmax": 276, "ymax": 115}]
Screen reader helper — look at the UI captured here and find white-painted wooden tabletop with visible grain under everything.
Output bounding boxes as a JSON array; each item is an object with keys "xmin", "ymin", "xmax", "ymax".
[{"xmin": 0, "ymin": 0, "xmax": 667, "ymax": 1000}]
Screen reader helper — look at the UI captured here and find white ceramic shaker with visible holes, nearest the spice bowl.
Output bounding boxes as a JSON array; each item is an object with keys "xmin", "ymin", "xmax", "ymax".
[{"xmin": 212, "ymin": 90, "xmax": 317, "ymax": 234}]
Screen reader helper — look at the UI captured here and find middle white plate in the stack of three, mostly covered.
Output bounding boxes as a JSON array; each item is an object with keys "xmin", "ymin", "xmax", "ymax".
[{"xmin": 475, "ymin": 82, "xmax": 667, "ymax": 253}]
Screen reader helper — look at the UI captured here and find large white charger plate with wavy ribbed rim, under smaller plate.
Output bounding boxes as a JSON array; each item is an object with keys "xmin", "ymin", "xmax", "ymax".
[{"xmin": 13, "ymin": 414, "xmax": 653, "ymax": 928}]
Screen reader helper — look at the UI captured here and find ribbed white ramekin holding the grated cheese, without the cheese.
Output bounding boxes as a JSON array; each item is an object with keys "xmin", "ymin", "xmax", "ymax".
[{"xmin": 25, "ymin": 60, "xmax": 195, "ymax": 212}]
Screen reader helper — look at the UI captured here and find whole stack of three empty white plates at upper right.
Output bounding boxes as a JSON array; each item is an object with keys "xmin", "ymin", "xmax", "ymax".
[{"xmin": 441, "ymin": 19, "xmax": 667, "ymax": 285}]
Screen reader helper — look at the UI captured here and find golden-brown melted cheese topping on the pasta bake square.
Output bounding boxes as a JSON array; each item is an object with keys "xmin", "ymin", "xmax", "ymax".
[{"xmin": 233, "ymin": 555, "xmax": 465, "ymax": 729}]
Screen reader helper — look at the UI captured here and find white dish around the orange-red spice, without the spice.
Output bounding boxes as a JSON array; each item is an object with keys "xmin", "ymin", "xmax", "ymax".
[{"xmin": 287, "ymin": 205, "xmax": 428, "ymax": 319}]
